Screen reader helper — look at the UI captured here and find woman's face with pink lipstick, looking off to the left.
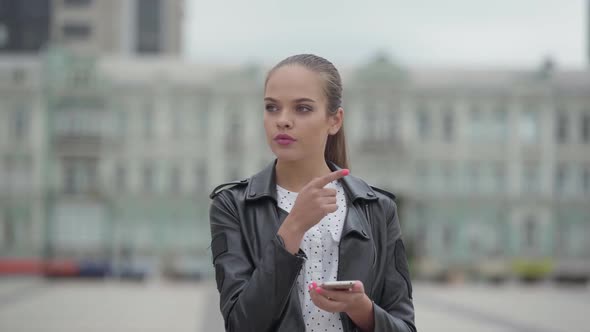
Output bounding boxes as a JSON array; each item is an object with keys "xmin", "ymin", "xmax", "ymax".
[{"xmin": 264, "ymin": 65, "xmax": 343, "ymax": 161}]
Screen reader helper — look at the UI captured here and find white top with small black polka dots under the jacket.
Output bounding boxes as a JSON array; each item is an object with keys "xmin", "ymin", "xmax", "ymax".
[{"xmin": 277, "ymin": 181, "xmax": 347, "ymax": 332}]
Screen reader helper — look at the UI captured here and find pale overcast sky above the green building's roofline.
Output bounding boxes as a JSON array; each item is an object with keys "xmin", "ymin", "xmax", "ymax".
[{"xmin": 185, "ymin": 0, "xmax": 590, "ymax": 68}]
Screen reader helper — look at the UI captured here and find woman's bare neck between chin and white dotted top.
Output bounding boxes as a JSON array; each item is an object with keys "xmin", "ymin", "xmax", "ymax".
[{"xmin": 275, "ymin": 156, "xmax": 332, "ymax": 192}]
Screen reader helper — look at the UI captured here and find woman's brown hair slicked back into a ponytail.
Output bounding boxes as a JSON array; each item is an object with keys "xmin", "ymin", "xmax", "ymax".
[{"xmin": 264, "ymin": 54, "xmax": 349, "ymax": 168}]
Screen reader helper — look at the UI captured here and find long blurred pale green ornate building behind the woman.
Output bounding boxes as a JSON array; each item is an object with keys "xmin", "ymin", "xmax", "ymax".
[{"xmin": 0, "ymin": 50, "xmax": 590, "ymax": 280}]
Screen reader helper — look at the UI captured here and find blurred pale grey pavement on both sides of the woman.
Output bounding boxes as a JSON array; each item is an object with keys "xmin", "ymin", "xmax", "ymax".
[{"xmin": 0, "ymin": 279, "xmax": 590, "ymax": 332}]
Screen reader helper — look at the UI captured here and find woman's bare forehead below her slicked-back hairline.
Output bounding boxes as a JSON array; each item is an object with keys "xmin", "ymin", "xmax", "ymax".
[{"xmin": 264, "ymin": 65, "xmax": 324, "ymax": 101}]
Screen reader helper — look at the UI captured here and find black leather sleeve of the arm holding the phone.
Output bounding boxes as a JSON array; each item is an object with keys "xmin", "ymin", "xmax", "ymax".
[{"xmin": 373, "ymin": 200, "xmax": 416, "ymax": 332}]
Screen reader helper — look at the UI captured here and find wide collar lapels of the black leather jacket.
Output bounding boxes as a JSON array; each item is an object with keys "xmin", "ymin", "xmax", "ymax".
[{"xmin": 246, "ymin": 159, "xmax": 377, "ymax": 202}]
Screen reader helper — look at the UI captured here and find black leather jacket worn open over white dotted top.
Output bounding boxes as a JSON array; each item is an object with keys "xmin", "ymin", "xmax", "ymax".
[{"xmin": 210, "ymin": 160, "xmax": 416, "ymax": 332}]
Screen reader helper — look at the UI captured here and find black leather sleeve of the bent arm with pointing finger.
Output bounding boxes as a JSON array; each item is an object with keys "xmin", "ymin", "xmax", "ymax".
[{"xmin": 209, "ymin": 191, "xmax": 305, "ymax": 332}]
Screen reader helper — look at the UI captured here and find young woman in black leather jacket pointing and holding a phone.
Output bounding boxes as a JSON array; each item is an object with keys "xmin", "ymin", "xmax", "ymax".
[{"xmin": 210, "ymin": 54, "xmax": 416, "ymax": 332}]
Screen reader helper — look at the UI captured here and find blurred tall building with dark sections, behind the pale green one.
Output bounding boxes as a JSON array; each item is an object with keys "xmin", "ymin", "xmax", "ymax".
[{"xmin": 0, "ymin": 0, "xmax": 184, "ymax": 57}]
